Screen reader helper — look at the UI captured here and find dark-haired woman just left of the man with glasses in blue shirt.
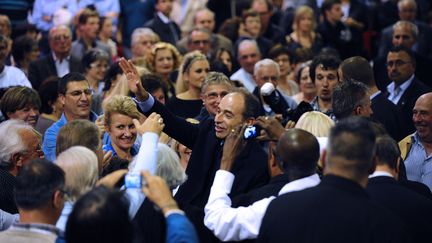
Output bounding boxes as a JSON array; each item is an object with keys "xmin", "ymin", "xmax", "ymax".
[{"xmin": 35, "ymin": 76, "xmax": 63, "ymax": 134}]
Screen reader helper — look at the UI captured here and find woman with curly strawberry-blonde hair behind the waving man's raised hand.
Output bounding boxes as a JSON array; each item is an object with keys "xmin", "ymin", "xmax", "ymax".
[{"xmin": 146, "ymin": 42, "xmax": 182, "ymax": 97}]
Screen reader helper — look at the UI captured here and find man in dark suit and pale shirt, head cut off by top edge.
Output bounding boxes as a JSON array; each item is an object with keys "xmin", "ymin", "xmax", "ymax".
[{"xmin": 145, "ymin": 0, "xmax": 181, "ymax": 46}]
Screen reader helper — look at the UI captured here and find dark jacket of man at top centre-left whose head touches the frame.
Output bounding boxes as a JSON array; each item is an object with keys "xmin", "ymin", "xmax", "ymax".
[{"xmin": 144, "ymin": 14, "xmax": 181, "ymax": 46}]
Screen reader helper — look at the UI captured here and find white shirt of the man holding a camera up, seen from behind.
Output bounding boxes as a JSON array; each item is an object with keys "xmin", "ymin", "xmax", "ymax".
[{"xmin": 204, "ymin": 170, "xmax": 320, "ymax": 241}]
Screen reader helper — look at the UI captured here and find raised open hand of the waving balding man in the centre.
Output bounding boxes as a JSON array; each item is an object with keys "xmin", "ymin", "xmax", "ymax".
[{"xmin": 119, "ymin": 58, "xmax": 148, "ymax": 101}]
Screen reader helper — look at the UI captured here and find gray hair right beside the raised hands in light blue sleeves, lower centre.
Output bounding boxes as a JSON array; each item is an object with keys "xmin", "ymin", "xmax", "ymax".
[{"xmin": 156, "ymin": 143, "xmax": 187, "ymax": 189}]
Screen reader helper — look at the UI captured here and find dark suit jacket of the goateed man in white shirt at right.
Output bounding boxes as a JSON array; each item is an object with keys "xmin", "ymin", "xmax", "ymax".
[{"xmin": 384, "ymin": 77, "xmax": 431, "ymax": 136}]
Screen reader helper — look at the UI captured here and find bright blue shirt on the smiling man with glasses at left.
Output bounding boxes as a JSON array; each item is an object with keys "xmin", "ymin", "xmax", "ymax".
[{"xmin": 42, "ymin": 111, "xmax": 97, "ymax": 161}]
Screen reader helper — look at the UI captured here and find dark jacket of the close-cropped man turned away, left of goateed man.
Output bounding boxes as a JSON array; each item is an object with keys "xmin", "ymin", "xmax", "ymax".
[{"xmin": 371, "ymin": 93, "xmax": 406, "ymax": 141}]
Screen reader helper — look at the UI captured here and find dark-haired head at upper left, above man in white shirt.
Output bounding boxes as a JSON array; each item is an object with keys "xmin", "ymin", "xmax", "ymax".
[{"xmin": 12, "ymin": 35, "xmax": 40, "ymax": 76}]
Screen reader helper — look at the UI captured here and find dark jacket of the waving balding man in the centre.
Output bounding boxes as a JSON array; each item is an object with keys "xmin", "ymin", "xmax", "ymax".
[{"xmin": 143, "ymin": 101, "xmax": 269, "ymax": 209}]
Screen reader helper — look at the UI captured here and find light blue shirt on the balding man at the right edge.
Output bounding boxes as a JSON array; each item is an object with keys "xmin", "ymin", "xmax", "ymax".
[{"xmin": 404, "ymin": 132, "xmax": 432, "ymax": 190}]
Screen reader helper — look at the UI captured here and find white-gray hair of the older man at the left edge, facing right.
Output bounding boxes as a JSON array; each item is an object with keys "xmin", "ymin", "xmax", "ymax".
[{"xmin": 0, "ymin": 119, "xmax": 34, "ymax": 169}]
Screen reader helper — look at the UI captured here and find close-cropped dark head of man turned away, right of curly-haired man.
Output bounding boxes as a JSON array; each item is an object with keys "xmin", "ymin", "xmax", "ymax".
[{"xmin": 339, "ymin": 56, "xmax": 375, "ymax": 87}]
